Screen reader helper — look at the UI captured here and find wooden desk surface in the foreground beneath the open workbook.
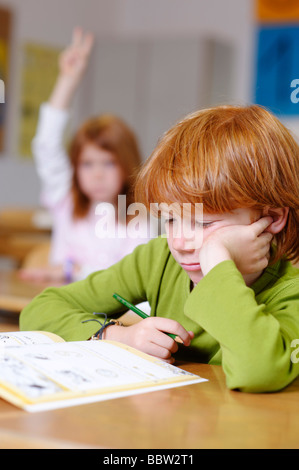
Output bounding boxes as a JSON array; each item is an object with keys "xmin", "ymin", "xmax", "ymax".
[{"xmin": 0, "ymin": 364, "xmax": 299, "ymax": 449}]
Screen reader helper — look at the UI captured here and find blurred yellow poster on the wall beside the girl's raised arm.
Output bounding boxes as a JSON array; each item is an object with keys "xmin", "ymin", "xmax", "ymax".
[{"xmin": 19, "ymin": 44, "xmax": 60, "ymax": 157}]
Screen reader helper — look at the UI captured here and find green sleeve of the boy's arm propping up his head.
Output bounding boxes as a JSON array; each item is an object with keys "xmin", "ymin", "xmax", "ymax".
[{"xmin": 185, "ymin": 261, "xmax": 299, "ymax": 392}]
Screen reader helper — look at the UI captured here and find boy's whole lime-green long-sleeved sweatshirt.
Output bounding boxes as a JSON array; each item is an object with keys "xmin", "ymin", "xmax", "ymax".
[{"xmin": 20, "ymin": 238, "xmax": 299, "ymax": 392}]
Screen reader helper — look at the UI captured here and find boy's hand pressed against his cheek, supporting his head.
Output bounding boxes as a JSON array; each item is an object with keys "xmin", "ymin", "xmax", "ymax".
[{"xmin": 199, "ymin": 217, "xmax": 273, "ymax": 275}]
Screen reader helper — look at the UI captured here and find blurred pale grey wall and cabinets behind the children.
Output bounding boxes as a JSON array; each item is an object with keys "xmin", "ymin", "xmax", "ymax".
[{"xmin": 0, "ymin": 0, "xmax": 299, "ymax": 207}]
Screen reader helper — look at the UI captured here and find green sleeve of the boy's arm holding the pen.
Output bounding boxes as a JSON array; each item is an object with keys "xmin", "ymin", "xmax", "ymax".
[{"xmin": 20, "ymin": 240, "xmax": 161, "ymax": 341}]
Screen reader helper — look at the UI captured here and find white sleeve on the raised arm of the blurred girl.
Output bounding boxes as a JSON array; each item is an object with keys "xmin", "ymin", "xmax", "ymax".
[{"xmin": 32, "ymin": 103, "xmax": 72, "ymax": 208}]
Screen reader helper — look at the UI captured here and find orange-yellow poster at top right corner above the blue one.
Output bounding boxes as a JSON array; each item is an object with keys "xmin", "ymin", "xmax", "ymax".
[{"xmin": 256, "ymin": 0, "xmax": 299, "ymax": 23}]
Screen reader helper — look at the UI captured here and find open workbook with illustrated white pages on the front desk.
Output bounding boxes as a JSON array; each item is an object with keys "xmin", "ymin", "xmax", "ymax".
[{"xmin": 0, "ymin": 331, "xmax": 206, "ymax": 411}]
